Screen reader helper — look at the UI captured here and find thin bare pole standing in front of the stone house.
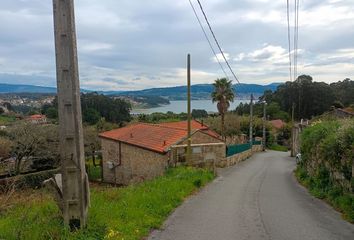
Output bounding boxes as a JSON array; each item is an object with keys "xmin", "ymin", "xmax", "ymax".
[{"xmin": 187, "ymin": 54, "xmax": 192, "ymax": 165}]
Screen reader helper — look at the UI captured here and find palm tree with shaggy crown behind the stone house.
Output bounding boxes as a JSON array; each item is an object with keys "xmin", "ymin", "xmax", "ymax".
[{"xmin": 211, "ymin": 78, "xmax": 235, "ymax": 139}]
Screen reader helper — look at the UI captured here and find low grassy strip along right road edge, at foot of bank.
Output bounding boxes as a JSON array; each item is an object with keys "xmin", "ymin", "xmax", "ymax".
[{"xmin": 295, "ymin": 166, "xmax": 354, "ymax": 223}]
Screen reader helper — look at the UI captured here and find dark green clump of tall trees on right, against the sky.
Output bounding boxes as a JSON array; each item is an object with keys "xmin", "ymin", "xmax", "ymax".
[{"xmin": 258, "ymin": 75, "xmax": 354, "ymax": 120}]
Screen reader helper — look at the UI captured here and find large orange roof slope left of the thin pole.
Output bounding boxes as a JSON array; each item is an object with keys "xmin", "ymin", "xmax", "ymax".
[{"xmin": 99, "ymin": 123, "xmax": 187, "ymax": 153}]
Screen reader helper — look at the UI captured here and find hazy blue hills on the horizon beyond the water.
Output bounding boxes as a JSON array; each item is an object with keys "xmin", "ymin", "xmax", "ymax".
[{"xmin": 0, "ymin": 83, "xmax": 281, "ymax": 100}]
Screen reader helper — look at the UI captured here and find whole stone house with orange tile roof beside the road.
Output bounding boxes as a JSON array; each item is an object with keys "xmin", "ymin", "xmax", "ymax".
[{"xmin": 99, "ymin": 121, "xmax": 225, "ymax": 185}]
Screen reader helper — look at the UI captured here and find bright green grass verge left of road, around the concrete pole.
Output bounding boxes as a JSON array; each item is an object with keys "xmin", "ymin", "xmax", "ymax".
[{"xmin": 0, "ymin": 167, "xmax": 214, "ymax": 240}]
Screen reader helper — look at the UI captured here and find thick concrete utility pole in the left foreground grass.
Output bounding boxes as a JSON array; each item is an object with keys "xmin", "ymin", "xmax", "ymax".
[{"xmin": 53, "ymin": 0, "xmax": 89, "ymax": 229}]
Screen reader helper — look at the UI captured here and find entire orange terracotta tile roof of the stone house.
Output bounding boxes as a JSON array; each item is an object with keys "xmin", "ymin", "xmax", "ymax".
[{"xmin": 99, "ymin": 121, "xmax": 220, "ymax": 153}]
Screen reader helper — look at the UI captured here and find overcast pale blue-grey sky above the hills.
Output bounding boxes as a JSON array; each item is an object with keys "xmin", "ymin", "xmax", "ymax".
[{"xmin": 0, "ymin": 0, "xmax": 354, "ymax": 90}]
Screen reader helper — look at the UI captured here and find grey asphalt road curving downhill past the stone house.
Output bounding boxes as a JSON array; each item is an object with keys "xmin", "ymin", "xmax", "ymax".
[{"xmin": 149, "ymin": 151, "xmax": 354, "ymax": 240}]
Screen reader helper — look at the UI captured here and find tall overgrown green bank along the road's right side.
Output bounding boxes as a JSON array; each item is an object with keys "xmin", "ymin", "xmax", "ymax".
[{"xmin": 296, "ymin": 119, "xmax": 354, "ymax": 222}]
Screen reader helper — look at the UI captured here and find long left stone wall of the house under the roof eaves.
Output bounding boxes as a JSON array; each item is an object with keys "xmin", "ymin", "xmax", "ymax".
[{"xmin": 102, "ymin": 138, "xmax": 169, "ymax": 185}]
